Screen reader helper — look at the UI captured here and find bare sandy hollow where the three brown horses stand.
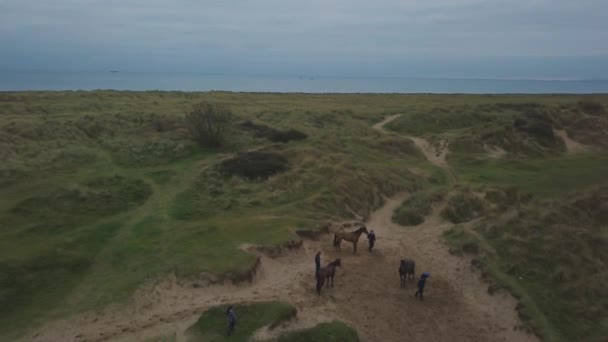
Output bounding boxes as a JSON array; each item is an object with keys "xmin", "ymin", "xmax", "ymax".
[{"xmin": 29, "ymin": 116, "xmax": 537, "ymax": 341}]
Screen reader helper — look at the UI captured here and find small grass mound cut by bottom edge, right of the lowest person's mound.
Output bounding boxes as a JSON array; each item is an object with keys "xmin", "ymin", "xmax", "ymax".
[{"xmin": 277, "ymin": 321, "xmax": 359, "ymax": 342}]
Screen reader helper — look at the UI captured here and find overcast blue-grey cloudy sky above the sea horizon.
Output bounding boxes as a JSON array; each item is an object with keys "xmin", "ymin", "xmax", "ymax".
[{"xmin": 0, "ymin": 0, "xmax": 608, "ymax": 79}]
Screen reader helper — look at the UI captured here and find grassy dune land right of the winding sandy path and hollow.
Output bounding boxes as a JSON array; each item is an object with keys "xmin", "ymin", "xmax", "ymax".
[{"xmin": 391, "ymin": 99, "xmax": 608, "ymax": 341}]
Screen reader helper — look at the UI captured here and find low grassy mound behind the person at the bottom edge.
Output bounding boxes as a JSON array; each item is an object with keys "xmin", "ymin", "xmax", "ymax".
[{"xmin": 188, "ymin": 301, "xmax": 297, "ymax": 342}]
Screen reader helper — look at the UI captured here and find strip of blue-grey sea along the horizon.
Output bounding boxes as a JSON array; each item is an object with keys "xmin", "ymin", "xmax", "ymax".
[{"xmin": 0, "ymin": 71, "xmax": 608, "ymax": 94}]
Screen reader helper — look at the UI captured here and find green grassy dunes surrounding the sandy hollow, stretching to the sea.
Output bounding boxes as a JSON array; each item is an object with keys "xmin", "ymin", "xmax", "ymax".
[{"xmin": 0, "ymin": 91, "xmax": 608, "ymax": 340}]
